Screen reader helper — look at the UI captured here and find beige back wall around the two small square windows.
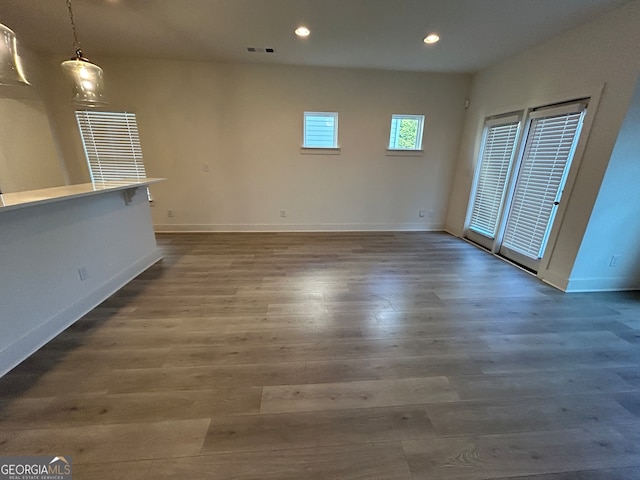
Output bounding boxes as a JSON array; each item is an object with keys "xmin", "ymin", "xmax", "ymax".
[{"xmin": 41, "ymin": 59, "xmax": 469, "ymax": 231}]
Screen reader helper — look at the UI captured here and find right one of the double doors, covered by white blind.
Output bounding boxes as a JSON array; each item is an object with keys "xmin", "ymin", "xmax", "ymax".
[{"xmin": 501, "ymin": 104, "xmax": 585, "ymax": 270}]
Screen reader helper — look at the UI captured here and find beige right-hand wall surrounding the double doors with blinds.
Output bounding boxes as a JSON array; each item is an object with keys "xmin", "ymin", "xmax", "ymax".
[{"xmin": 446, "ymin": 0, "xmax": 640, "ymax": 289}]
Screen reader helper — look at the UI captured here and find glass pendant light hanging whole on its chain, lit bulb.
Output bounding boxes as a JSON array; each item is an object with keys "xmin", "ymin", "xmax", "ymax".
[{"xmin": 61, "ymin": 0, "xmax": 107, "ymax": 107}]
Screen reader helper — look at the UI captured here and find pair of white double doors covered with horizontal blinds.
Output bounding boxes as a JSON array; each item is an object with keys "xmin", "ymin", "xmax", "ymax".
[{"xmin": 466, "ymin": 103, "xmax": 586, "ymax": 272}]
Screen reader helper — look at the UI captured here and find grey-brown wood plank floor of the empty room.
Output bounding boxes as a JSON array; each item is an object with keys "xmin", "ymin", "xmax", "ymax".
[{"xmin": 0, "ymin": 233, "xmax": 640, "ymax": 480}]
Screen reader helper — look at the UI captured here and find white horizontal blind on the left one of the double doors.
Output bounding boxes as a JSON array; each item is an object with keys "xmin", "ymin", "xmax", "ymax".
[{"xmin": 469, "ymin": 116, "xmax": 520, "ymax": 239}]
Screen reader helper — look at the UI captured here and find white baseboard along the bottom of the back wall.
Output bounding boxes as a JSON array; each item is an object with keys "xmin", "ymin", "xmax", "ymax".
[{"xmin": 154, "ymin": 223, "xmax": 444, "ymax": 233}]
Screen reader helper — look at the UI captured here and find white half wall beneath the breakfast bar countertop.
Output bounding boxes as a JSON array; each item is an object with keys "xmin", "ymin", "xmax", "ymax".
[{"xmin": 0, "ymin": 191, "xmax": 160, "ymax": 376}]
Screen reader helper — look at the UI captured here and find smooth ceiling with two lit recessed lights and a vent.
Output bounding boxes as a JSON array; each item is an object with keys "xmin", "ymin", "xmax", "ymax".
[{"xmin": 0, "ymin": 0, "xmax": 628, "ymax": 72}]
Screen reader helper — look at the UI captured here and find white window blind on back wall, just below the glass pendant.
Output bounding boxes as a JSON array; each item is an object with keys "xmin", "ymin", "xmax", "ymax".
[{"xmin": 76, "ymin": 110, "xmax": 147, "ymax": 183}]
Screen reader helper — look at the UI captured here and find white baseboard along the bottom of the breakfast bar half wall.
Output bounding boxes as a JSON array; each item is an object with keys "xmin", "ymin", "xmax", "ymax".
[{"xmin": 0, "ymin": 249, "xmax": 162, "ymax": 377}]
